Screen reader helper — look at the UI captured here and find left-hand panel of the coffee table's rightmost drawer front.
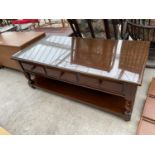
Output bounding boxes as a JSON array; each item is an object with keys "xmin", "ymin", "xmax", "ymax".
[{"xmin": 79, "ymin": 75, "xmax": 99, "ymax": 88}]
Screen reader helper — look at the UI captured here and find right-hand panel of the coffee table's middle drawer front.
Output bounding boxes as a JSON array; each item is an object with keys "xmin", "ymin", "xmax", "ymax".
[{"xmin": 61, "ymin": 72, "xmax": 77, "ymax": 83}]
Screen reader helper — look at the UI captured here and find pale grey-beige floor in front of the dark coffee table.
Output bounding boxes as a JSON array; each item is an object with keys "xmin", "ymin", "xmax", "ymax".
[{"xmin": 0, "ymin": 68, "xmax": 154, "ymax": 135}]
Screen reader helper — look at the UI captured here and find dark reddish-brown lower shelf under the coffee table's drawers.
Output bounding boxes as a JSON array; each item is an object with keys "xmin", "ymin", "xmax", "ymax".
[{"xmin": 33, "ymin": 76, "xmax": 125, "ymax": 118}]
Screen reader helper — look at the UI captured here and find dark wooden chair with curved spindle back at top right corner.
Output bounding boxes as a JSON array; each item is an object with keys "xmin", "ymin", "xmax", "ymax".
[{"xmin": 127, "ymin": 19, "xmax": 155, "ymax": 68}]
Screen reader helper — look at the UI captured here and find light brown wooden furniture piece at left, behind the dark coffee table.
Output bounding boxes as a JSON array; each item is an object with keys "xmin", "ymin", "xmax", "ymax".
[{"xmin": 0, "ymin": 32, "xmax": 45, "ymax": 70}]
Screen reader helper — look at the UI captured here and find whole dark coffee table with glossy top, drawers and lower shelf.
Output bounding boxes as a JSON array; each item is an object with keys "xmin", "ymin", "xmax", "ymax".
[{"xmin": 13, "ymin": 35, "xmax": 149, "ymax": 121}]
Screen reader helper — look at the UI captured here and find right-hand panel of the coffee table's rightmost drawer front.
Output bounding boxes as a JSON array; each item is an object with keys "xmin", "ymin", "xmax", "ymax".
[{"xmin": 100, "ymin": 80, "xmax": 123, "ymax": 93}]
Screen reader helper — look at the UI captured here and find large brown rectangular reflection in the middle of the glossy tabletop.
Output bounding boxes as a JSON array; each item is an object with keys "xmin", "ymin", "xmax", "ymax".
[{"xmin": 71, "ymin": 38, "xmax": 117, "ymax": 72}]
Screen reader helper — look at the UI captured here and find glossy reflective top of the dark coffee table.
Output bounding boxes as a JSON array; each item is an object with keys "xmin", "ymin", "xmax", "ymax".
[{"xmin": 13, "ymin": 35, "xmax": 149, "ymax": 84}]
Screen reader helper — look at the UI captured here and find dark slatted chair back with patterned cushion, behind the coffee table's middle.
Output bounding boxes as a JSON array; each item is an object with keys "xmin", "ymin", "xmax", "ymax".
[{"xmin": 68, "ymin": 19, "xmax": 122, "ymax": 39}]
